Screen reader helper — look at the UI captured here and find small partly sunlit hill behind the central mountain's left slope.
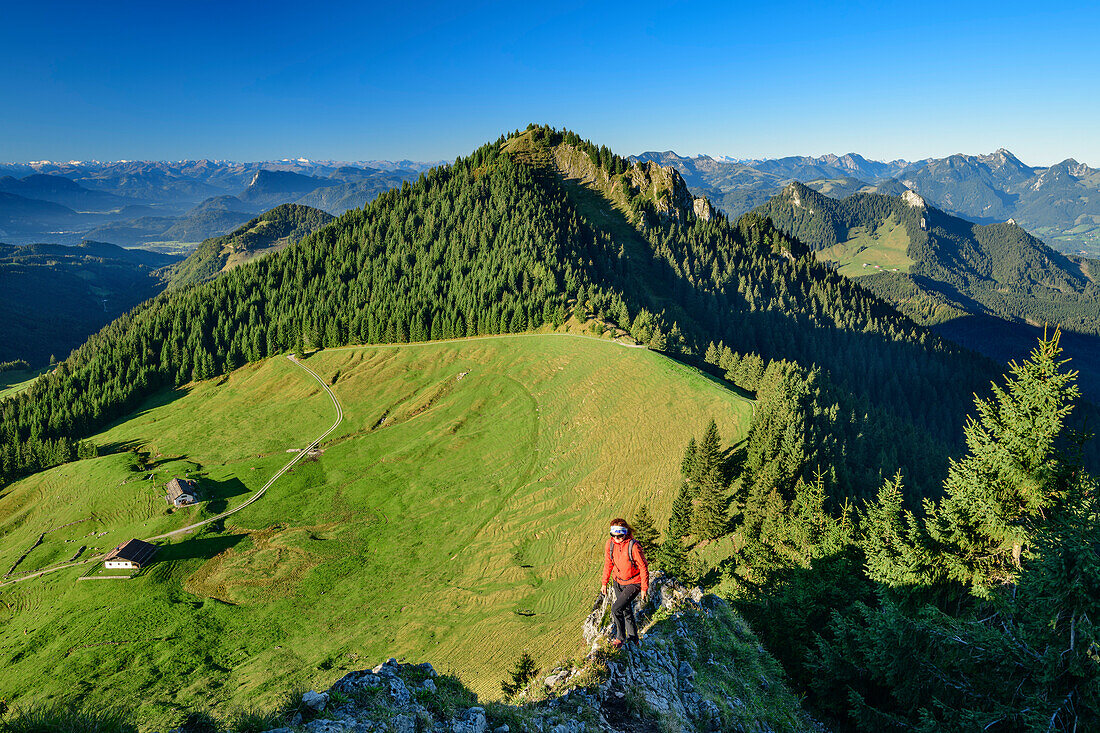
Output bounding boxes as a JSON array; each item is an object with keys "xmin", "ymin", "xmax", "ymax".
[{"xmin": 167, "ymin": 204, "xmax": 332, "ymax": 288}]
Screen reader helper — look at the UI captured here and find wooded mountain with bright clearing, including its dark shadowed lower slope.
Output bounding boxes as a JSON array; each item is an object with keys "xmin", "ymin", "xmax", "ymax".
[{"xmin": 758, "ymin": 183, "xmax": 1100, "ymax": 400}]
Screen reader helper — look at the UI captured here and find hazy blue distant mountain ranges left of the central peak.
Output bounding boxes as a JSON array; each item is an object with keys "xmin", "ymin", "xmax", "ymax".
[{"xmin": 0, "ymin": 158, "xmax": 436, "ymax": 245}]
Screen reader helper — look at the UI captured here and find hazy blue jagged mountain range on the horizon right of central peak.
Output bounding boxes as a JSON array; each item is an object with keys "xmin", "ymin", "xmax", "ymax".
[{"xmin": 636, "ymin": 149, "xmax": 1100, "ymax": 255}]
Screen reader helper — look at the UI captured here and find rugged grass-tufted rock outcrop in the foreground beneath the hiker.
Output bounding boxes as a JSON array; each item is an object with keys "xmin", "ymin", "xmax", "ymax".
[{"xmin": 251, "ymin": 575, "xmax": 816, "ymax": 733}]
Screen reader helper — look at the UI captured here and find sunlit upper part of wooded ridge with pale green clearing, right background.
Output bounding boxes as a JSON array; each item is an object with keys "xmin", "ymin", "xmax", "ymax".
[{"xmin": 758, "ymin": 183, "xmax": 1100, "ymax": 333}]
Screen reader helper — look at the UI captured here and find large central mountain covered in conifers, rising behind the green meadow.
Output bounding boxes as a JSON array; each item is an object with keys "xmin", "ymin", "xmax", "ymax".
[{"xmin": 0, "ymin": 128, "xmax": 1091, "ymax": 495}]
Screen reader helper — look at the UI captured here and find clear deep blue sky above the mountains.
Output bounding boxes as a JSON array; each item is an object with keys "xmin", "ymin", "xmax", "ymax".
[{"xmin": 0, "ymin": 0, "xmax": 1100, "ymax": 167}]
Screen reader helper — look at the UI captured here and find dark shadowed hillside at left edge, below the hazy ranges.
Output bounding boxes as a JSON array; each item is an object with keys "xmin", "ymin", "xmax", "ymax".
[{"xmin": 0, "ymin": 242, "xmax": 177, "ymax": 365}]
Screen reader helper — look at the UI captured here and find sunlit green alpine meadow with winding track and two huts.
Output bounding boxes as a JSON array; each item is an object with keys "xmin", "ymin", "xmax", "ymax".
[{"xmin": 0, "ymin": 336, "xmax": 751, "ymax": 730}]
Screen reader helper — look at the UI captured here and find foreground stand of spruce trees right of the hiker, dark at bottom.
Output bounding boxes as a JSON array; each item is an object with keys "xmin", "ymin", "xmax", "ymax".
[{"xmin": 634, "ymin": 332, "xmax": 1100, "ymax": 733}]
